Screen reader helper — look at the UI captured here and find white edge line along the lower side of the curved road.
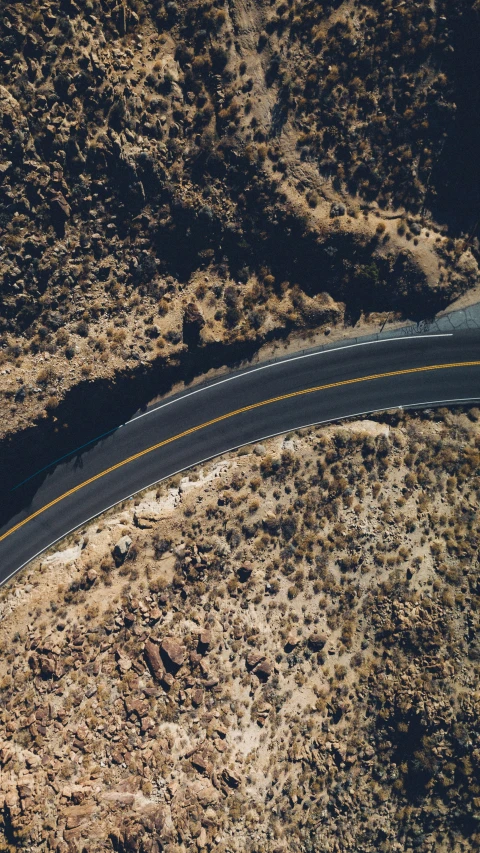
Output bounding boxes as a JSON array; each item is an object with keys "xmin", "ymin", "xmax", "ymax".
[{"xmin": 0, "ymin": 397, "xmax": 480, "ymax": 588}]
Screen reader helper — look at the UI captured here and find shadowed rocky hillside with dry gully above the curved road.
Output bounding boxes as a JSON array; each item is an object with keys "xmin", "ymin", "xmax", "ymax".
[{"xmin": 0, "ymin": 0, "xmax": 480, "ymax": 436}]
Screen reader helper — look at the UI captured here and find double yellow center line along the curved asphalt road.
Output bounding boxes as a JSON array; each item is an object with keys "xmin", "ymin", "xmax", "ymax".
[{"xmin": 0, "ymin": 361, "xmax": 480, "ymax": 542}]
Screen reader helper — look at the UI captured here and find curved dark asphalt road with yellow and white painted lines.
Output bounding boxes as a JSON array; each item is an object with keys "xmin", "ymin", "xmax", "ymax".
[{"xmin": 0, "ymin": 330, "xmax": 480, "ymax": 584}]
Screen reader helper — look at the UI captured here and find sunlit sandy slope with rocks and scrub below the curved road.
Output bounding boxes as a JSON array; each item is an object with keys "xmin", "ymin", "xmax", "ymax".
[{"xmin": 0, "ymin": 409, "xmax": 480, "ymax": 853}]
